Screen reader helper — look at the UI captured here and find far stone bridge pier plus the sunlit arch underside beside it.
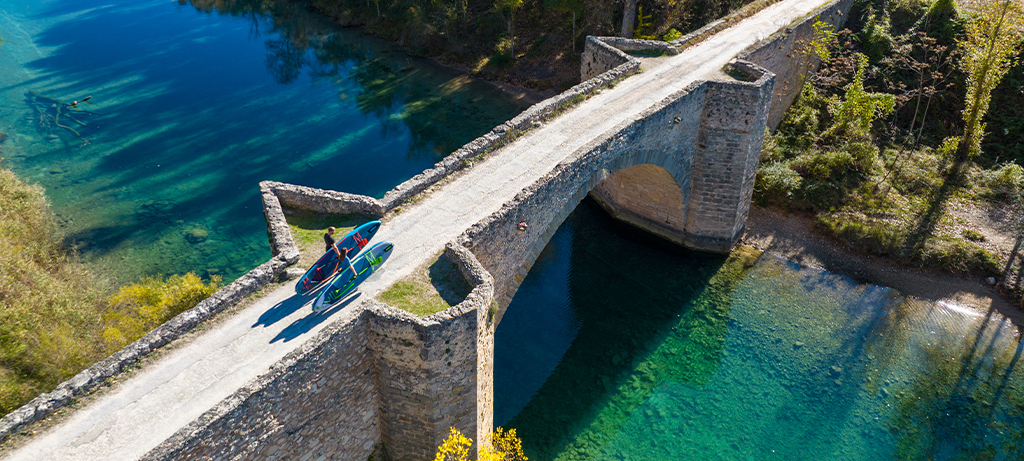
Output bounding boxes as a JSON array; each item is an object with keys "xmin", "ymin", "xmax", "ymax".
[{"xmin": 590, "ymin": 61, "xmax": 773, "ymax": 253}]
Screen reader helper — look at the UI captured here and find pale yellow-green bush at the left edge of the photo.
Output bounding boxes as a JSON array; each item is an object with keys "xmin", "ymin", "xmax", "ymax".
[{"xmin": 0, "ymin": 169, "xmax": 103, "ymax": 414}]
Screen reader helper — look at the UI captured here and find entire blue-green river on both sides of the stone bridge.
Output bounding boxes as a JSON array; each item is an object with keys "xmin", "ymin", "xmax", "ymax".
[{"xmin": 0, "ymin": 0, "xmax": 1024, "ymax": 461}]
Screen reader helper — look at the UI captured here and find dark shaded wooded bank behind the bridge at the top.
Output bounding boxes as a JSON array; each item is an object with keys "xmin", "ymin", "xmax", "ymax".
[{"xmin": 290, "ymin": 0, "xmax": 761, "ymax": 91}]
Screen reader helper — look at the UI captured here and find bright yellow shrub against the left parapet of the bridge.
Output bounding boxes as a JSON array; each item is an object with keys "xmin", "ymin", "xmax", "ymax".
[{"xmin": 103, "ymin": 273, "xmax": 220, "ymax": 352}]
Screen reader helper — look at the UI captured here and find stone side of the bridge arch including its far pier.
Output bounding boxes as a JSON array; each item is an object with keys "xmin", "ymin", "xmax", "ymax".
[{"xmin": 458, "ymin": 66, "xmax": 773, "ymax": 323}]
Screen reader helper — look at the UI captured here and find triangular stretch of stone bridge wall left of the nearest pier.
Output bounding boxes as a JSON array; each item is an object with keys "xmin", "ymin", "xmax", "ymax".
[{"xmin": 143, "ymin": 311, "xmax": 381, "ymax": 461}]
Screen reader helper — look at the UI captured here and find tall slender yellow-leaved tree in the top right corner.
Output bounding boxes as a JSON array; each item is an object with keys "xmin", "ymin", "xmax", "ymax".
[{"xmin": 956, "ymin": 0, "xmax": 1024, "ymax": 160}]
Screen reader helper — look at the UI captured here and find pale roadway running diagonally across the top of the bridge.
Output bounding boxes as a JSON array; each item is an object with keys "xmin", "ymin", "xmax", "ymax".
[{"xmin": 7, "ymin": 0, "xmax": 824, "ymax": 461}]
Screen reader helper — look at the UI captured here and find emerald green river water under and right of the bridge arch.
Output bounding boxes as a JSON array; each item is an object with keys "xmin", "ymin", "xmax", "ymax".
[{"xmin": 495, "ymin": 202, "xmax": 1024, "ymax": 461}]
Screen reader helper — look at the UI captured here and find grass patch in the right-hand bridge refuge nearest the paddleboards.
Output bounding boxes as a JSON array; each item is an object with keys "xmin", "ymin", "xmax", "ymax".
[{"xmin": 380, "ymin": 253, "xmax": 472, "ymax": 317}]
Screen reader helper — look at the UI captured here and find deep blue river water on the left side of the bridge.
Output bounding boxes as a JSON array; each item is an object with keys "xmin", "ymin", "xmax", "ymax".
[{"xmin": 0, "ymin": 0, "xmax": 522, "ymax": 283}]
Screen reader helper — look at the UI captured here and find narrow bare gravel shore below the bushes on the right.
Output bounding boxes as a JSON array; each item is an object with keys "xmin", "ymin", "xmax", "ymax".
[{"xmin": 740, "ymin": 206, "xmax": 1024, "ymax": 325}]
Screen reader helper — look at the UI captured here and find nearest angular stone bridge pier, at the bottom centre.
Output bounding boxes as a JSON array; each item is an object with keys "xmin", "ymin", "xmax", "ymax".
[{"xmin": 368, "ymin": 244, "xmax": 494, "ymax": 461}]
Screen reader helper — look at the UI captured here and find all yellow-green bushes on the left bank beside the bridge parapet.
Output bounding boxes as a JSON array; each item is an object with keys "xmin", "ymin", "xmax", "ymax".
[{"xmin": 0, "ymin": 160, "xmax": 218, "ymax": 414}]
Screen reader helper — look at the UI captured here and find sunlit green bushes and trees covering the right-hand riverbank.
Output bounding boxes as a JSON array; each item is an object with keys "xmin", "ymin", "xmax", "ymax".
[{"xmin": 755, "ymin": 0, "xmax": 1024, "ymax": 276}]
